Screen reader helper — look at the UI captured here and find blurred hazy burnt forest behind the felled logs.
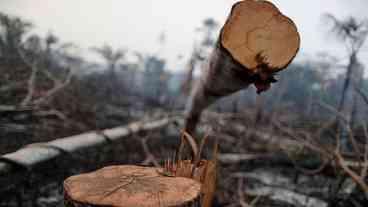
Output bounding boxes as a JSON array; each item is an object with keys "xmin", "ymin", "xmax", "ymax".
[{"xmin": 0, "ymin": 11, "xmax": 368, "ymax": 153}]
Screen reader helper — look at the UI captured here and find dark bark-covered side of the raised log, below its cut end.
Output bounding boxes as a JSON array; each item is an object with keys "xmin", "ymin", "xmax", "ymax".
[{"xmin": 184, "ymin": 43, "xmax": 256, "ymax": 134}]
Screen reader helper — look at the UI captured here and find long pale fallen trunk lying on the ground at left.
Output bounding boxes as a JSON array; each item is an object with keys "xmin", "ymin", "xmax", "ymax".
[{"xmin": 0, "ymin": 118, "xmax": 175, "ymax": 192}]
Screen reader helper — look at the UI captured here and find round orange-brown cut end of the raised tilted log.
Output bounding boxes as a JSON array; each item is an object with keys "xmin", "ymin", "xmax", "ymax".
[{"xmin": 221, "ymin": 0, "xmax": 300, "ymax": 72}]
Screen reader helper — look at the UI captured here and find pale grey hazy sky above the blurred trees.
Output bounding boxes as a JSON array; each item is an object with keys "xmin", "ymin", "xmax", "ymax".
[{"xmin": 0, "ymin": 0, "xmax": 368, "ymax": 69}]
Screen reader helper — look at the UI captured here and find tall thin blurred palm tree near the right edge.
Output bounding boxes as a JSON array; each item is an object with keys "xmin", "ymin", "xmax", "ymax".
[{"xmin": 325, "ymin": 14, "xmax": 368, "ymax": 151}]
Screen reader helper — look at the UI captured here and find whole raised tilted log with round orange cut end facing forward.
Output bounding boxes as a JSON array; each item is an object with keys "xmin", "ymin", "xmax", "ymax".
[{"xmin": 185, "ymin": 0, "xmax": 300, "ymax": 133}]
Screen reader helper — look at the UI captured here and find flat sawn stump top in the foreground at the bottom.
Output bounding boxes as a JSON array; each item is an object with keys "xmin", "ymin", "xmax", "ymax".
[{"xmin": 64, "ymin": 165, "xmax": 201, "ymax": 207}]
